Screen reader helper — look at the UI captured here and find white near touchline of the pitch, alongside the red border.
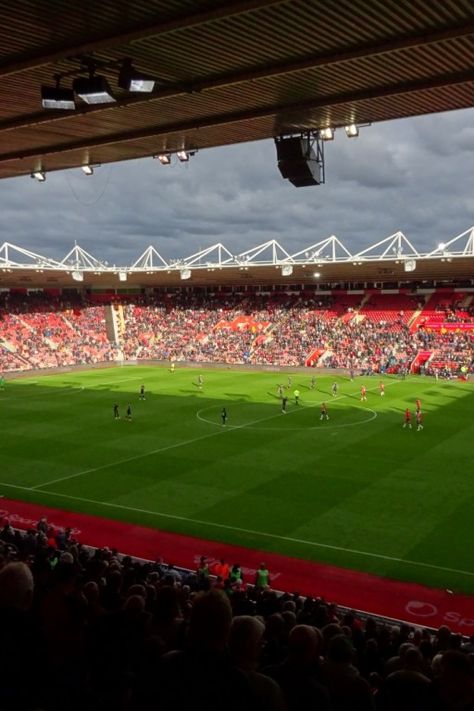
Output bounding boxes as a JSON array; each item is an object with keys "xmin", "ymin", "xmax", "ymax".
[{"xmin": 0, "ymin": 482, "xmax": 474, "ymax": 577}]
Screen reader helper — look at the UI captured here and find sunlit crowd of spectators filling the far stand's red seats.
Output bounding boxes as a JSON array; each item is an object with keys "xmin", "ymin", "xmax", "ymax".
[{"xmin": 0, "ymin": 291, "xmax": 474, "ymax": 374}]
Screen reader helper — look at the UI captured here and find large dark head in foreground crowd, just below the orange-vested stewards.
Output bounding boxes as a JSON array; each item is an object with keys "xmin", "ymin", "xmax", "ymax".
[{"xmin": 189, "ymin": 590, "xmax": 232, "ymax": 651}]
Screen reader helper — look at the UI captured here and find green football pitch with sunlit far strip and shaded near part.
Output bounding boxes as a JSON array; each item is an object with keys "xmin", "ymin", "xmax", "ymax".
[{"xmin": 0, "ymin": 366, "xmax": 474, "ymax": 593}]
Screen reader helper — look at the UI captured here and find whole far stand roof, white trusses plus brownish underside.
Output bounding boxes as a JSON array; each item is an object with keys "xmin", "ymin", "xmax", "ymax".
[{"xmin": 0, "ymin": 226, "xmax": 474, "ymax": 289}]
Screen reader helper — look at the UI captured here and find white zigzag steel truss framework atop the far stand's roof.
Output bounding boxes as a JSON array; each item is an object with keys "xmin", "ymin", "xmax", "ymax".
[{"xmin": 0, "ymin": 226, "xmax": 474, "ymax": 281}]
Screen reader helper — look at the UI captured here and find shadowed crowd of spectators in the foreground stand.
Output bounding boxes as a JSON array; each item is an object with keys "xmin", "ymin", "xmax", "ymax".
[{"xmin": 0, "ymin": 518, "xmax": 474, "ymax": 711}]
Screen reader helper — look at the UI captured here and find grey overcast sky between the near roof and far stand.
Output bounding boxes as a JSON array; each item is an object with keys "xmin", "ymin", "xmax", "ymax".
[{"xmin": 0, "ymin": 109, "xmax": 474, "ymax": 265}]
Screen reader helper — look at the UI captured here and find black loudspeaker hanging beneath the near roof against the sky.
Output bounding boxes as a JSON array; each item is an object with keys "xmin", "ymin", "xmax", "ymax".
[{"xmin": 275, "ymin": 136, "xmax": 323, "ymax": 188}]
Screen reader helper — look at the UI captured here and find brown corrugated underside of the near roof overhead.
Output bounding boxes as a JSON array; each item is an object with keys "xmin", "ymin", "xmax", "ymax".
[{"xmin": 0, "ymin": 0, "xmax": 474, "ymax": 178}]
